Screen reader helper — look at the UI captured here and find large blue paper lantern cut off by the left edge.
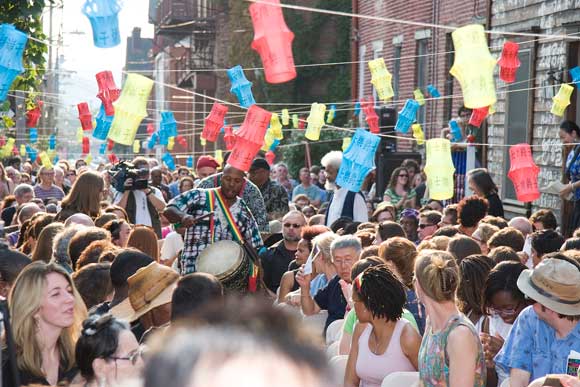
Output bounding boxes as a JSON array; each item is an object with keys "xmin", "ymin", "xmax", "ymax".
[{"xmin": 0, "ymin": 24, "xmax": 28, "ymax": 101}]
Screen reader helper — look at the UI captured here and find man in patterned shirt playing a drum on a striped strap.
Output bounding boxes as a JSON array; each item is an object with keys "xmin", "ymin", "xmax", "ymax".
[{"xmin": 163, "ymin": 165, "xmax": 263, "ymax": 275}]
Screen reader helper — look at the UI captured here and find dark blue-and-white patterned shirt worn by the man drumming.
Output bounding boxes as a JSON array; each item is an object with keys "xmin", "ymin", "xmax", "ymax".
[{"xmin": 167, "ymin": 189, "xmax": 263, "ymax": 275}]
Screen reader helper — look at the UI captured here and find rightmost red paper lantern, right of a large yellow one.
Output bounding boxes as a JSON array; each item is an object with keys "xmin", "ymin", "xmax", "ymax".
[{"xmin": 508, "ymin": 144, "xmax": 540, "ymax": 202}]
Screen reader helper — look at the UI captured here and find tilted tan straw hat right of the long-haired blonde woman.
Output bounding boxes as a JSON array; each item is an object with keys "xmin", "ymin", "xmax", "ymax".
[{"xmin": 111, "ymin": 262, "xmax": 179, "ymax": 322}]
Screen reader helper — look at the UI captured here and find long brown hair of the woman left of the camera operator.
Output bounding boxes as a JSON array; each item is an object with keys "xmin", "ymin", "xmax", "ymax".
[{"xmin": 56, "ymin": 171, "xmax": 105, "ymax": 222}]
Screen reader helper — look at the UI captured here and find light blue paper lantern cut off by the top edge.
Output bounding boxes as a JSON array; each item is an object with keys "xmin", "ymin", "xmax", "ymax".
[{"xmin": 82, "ymin": 0, "xmax": 121, "ymax": 48}]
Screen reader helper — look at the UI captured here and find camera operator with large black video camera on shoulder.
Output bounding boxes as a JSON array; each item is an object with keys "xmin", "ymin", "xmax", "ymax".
[{"xmin": 114, "ymin": 157, "xmax": 165, "ymax": 239}]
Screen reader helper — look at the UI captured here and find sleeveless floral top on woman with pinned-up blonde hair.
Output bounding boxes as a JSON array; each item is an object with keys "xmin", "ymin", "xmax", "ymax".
[{"xmin": 419, "ymin": 314, "xmax": 487, "ymax": 387}]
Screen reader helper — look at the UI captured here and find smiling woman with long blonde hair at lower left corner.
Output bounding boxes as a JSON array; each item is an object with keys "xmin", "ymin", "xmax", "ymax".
[{"xmin": 2, "ymin": 262, "xmax": 87, "ymax": 386}]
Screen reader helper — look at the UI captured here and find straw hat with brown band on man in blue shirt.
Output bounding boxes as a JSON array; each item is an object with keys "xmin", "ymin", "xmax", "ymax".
[{"xmin": 518, "ymin": 258, "xmax": 580, "ymax": 316}]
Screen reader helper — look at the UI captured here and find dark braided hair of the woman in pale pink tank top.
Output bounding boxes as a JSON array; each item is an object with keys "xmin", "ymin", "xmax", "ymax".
[{"xmin": 353, "ymin": 265, "xmax": 407, "ymax": 321}]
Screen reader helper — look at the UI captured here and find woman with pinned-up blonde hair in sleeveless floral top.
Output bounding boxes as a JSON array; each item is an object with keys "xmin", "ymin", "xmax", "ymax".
[{"xmin": 414, "ymin": 250, "xmax": 486, "ymax": 387}]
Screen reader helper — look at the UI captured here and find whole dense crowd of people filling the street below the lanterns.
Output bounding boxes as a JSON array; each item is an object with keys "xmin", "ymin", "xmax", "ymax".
[{"xmin": 0, "ymin": 137, "xmax": 580, "ymax": 387}]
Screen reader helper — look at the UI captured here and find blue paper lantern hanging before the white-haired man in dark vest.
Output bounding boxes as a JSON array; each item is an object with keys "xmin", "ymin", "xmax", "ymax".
[{"xmin": 336, "ymin": 128, "xmax": 381, "ymax": 192}]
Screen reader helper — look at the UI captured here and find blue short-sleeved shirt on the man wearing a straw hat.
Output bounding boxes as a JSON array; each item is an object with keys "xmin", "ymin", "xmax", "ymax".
[{"xmin": 494, "ymin": 306, "xmax": 580, "ymax": 381}]
